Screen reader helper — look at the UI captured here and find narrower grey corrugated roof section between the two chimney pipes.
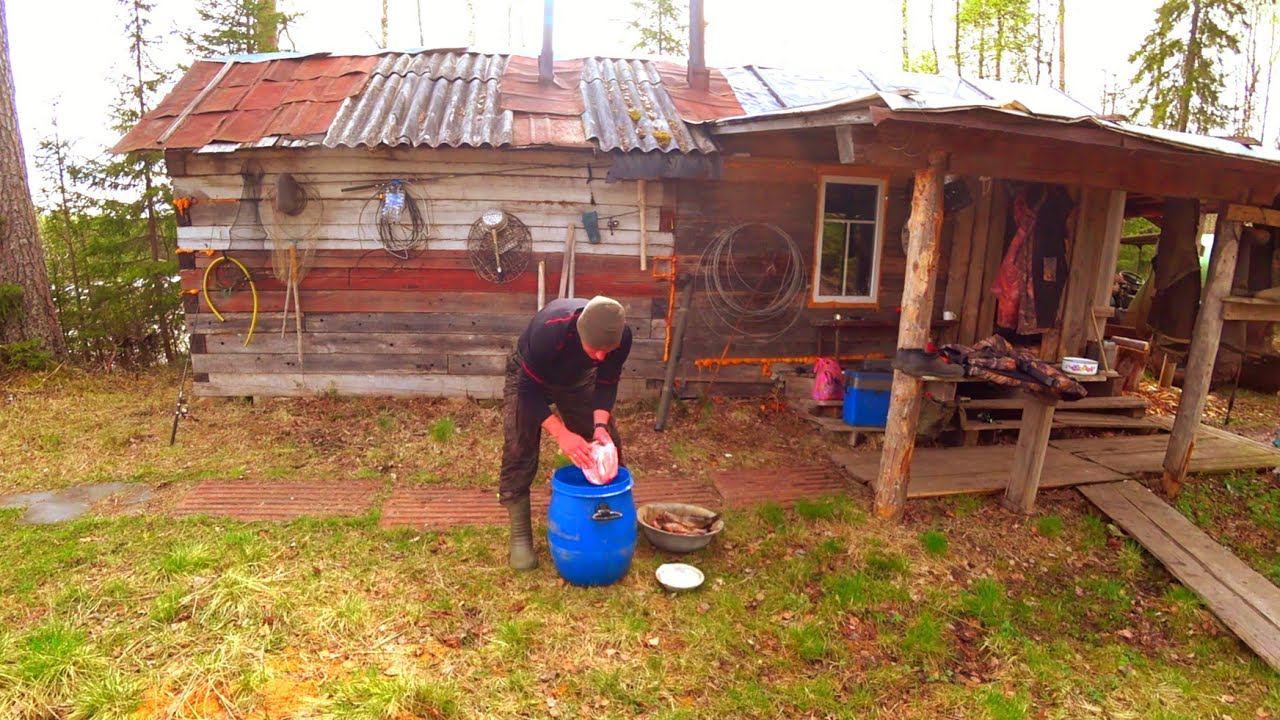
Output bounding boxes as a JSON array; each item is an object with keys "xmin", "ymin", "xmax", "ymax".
[{"xmin": 581, "ymin": 58, "xmax": 716, "ymax": 152}]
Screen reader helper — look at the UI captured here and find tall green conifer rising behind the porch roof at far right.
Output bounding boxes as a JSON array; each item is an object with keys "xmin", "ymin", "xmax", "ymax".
[{"xmin": 1129, "ymin": 0, "xmax": 1245, "ymax": 133}]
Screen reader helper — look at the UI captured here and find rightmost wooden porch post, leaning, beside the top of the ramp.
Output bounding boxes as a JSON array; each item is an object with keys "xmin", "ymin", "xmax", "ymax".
[{"xmin": 1162, "ymin": 208, "xmax": 1240, "ymax": 497}]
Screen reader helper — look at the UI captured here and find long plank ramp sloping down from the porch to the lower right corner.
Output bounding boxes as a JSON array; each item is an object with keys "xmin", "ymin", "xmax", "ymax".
[{"xmin": 1079, "ymin": 480, "xmax": 1280, "ymax": 670}]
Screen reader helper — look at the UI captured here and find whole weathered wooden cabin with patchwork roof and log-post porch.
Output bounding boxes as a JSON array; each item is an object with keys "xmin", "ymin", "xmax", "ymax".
[{"xmin": 114, "ymin": 15, "xmax": 1280, "ymax": 515}]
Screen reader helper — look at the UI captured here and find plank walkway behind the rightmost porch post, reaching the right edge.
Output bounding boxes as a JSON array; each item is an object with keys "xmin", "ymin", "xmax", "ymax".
[{"xmin": 1050, "ymin": 419, "xmax": 1280, "ymax": 475}]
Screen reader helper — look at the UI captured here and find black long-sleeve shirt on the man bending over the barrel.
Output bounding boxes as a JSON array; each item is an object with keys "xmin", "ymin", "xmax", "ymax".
[{"xmin": 516, "ymin": 297, "xmax": 631, "ymax": 421}]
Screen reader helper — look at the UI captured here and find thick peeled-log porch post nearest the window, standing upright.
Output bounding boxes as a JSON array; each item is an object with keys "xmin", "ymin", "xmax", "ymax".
[{"xmin": 876, "ymin": 152, "xmax": 947, "ymax": 519}]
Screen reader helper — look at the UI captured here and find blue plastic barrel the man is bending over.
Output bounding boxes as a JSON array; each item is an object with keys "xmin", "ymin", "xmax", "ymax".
[{"xmin": 547, "ymin": 465, "xmax": 636, "ymax": 585}]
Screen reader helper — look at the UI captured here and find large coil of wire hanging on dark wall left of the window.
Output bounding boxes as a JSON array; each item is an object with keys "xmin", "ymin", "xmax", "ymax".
[{"xmin": 698, "ymin": 223, "xmax": 805, "ymax": 341}]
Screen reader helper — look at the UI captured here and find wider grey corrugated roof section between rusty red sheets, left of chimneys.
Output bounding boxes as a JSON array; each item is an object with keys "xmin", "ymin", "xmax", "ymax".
[{"xmin": 324, "ymin": 53, "xmax": 512, "ymax": 147}]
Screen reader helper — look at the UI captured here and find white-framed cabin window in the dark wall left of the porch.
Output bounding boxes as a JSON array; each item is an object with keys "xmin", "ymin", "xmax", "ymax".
[{"xmin": 813, "ymin": 177, "xmax": 884, "ymax": 302}]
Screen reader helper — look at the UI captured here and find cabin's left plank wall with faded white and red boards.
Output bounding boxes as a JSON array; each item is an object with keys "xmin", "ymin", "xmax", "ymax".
[{"xmin": 180, "ymin": 149, "xmax": 673, "ymax": 397}]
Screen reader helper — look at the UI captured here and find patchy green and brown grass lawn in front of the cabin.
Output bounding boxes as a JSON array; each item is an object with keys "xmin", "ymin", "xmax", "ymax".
[{"xmin": 0, "ymin": 370, "xmax": 1280, "ymax": 720}]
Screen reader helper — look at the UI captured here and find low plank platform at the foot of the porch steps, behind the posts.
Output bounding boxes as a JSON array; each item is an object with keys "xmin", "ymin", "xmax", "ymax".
[{"xmin": 831, "ymin": 445, "xmax": 1125, "ymax": 497}]
